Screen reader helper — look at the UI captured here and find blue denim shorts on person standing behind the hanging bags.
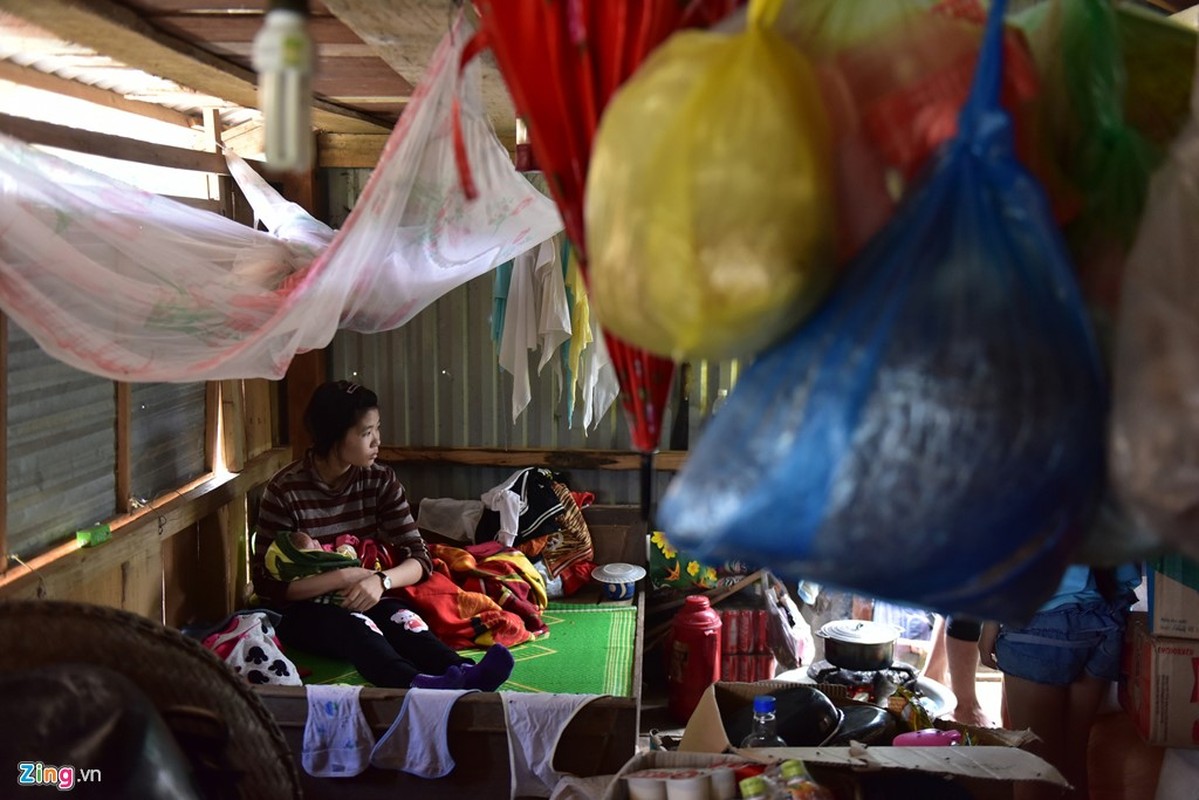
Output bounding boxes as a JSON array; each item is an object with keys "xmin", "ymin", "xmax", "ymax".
[{"xmin": 995, "ymin": 600, "xmax": 1128, "ymax": 686}]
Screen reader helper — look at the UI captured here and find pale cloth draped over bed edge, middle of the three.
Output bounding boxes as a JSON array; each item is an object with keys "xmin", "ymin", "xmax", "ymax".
[{"xmin": 370, "ymin": 688, "xmax": 478, "ymax": 777}]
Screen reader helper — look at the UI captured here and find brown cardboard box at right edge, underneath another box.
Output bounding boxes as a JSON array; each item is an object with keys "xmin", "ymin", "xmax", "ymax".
[{"xmin": 1117, "ymin": 613, "xmax": 1199, "ymax": 747}]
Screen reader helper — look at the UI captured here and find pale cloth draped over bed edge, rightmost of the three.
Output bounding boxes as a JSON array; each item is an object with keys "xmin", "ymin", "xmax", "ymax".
[{"xmin": 500, "ymin": 692, "xmax": 603, "ymax": 799}]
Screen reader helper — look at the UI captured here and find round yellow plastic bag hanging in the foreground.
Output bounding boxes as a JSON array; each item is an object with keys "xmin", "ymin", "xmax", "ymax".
[{"xmin": 584, "ymin": 0, "xmax": 836, "ymax": 360}]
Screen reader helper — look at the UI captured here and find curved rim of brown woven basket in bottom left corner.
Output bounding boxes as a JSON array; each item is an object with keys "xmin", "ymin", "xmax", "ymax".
[{"xmin": 0, "ymin": 600, "xmax": 301, "ymax": 800}]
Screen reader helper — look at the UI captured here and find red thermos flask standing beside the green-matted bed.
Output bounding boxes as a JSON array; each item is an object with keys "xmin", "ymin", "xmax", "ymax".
[{"xmin": 667, "ymin": 595, "xmax": 721, "ymax": 723}]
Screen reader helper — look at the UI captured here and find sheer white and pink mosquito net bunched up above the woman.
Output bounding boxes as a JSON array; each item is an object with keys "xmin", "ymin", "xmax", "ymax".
[{"xmin": 0, "ymin": 12, "xmax": 562, "ymax": 381}]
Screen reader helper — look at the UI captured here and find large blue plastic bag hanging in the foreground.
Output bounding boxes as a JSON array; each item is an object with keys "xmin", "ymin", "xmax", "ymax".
[{"xmin": 658, "ymin": 2, "xmax": 1108, "ymax": 620}]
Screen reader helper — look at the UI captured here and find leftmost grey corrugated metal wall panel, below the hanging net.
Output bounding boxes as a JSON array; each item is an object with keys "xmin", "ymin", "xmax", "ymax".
[{"xmin": 7, "ymin": 320, "xmax": 116, "ymax": 558}]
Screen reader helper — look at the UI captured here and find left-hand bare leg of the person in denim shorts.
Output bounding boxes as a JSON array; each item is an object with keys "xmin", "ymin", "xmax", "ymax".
[{"xmin": 1004, "ymin": 675, "xmax": 1069, "ymax": 800}]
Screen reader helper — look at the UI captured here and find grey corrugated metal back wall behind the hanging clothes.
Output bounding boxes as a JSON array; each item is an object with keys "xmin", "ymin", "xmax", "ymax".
[{"xmin": 326, "ymin": 169, "xmax": 737, "ymax": 503}]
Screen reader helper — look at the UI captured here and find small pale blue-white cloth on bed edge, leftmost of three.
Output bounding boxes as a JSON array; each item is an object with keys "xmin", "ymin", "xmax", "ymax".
[{"xmin": 300, "ymin": 684, "xmax": 374, "ymax": 777}]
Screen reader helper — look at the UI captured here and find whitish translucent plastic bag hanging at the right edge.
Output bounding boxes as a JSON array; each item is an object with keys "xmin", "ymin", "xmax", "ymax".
[{"xmin": 1110, "ymin": 40, "xmax": 1199, "ymax": 558}]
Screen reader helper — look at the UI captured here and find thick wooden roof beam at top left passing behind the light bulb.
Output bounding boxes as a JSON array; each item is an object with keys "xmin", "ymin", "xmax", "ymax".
[{"xmin": 0, "ymin": 0, "xmax": 390, "ymax": 133}]
